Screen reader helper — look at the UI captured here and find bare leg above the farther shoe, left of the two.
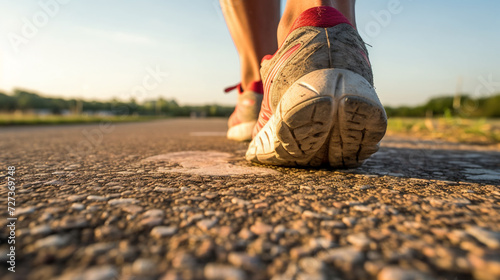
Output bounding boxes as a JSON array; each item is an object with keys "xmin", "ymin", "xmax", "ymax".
[{"xmin": 220, "ymin": 0, "xmax": 280, "ymax": 88}]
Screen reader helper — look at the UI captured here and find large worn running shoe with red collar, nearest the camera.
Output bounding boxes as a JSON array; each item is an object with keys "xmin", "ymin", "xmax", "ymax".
[{"xmin": 246, "ymin": 7, "xmax": 387, "ymax": 168}]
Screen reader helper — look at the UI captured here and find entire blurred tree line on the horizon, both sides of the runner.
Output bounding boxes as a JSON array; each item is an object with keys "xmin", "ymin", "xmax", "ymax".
[{"xmin": 0, "ymin": 89, "xmax": 500, "ymax": 118}]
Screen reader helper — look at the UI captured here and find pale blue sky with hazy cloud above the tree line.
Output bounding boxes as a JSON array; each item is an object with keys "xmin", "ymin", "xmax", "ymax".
[{"xmin": 0, "ymin": 0, "xmax": 500, "ymax": 105}]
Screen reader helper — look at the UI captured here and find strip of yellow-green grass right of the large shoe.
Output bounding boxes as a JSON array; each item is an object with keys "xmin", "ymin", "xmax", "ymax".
[{"xmin": 387, "ymin": 117, "xmax": 500, "ymax": 144}]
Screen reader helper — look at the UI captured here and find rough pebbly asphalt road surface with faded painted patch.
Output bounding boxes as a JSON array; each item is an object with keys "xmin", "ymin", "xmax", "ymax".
[{"xmin": 0, "ymin": 119, "xmax": 500, "ymax": 280}]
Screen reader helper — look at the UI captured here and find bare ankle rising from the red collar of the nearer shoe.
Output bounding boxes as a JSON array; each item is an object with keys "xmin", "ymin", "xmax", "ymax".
[{"xmin": 278, "ymin": 0, "xmax": 356, "ymax": 45}]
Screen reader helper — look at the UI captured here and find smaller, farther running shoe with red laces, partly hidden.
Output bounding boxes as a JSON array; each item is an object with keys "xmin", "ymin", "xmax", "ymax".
[{"xmin": 225, "ymin": 81, "xmax": 263, "ymax": 141}]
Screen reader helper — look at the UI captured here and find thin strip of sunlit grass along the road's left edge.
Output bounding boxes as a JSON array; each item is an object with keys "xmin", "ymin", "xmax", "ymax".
[{"xmin": 0, "ymin": 114, "xmax": 165, "ymax": 126}]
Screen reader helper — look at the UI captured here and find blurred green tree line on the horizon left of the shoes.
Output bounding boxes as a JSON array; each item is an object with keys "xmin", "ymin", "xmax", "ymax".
[{"xmin": 0, "ymin": 89, "xmax": 234, "ymax": 117}]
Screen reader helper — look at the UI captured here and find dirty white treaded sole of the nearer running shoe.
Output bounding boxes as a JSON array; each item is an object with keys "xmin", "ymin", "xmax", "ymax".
[{"xmin": 246, "ymin": 69, "xmax": 387, "ymax": 168}]
